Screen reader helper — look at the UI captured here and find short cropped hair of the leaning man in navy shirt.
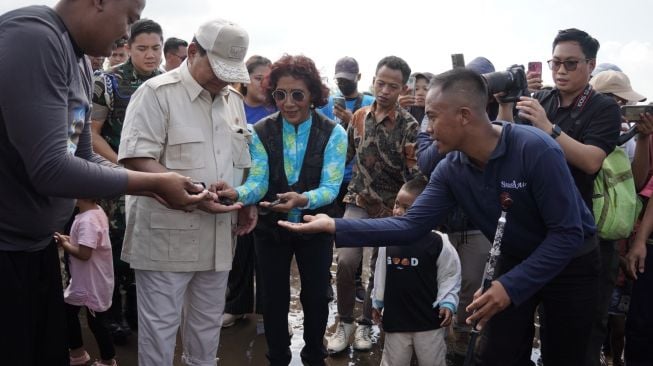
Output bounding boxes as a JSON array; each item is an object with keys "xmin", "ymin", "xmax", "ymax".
[{"xmin": 429, "ymin": 67, "xmax": 488, "ymax": 110}]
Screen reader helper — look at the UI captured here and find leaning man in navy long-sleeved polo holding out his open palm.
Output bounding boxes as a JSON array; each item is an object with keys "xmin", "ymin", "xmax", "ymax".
[{"xmin": 280, "ymin": 69, "xmax": 599, "ymax": 366}]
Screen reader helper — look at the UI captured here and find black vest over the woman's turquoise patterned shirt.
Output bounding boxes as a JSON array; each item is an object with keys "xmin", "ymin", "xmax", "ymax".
[{"xmin": 254, "ymin": 111, "xmax": 336, "ymax": 223}]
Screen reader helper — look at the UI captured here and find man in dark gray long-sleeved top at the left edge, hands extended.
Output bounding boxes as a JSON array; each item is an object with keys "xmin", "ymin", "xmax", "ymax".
[{"xmin": 0, "ymin": 0, "xmax": 215, "ymax": 365}]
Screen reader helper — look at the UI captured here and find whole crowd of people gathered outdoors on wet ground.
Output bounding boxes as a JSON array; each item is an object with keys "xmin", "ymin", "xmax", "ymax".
[{"xmin": 0, "ymin": 0, "xmax": 653, "ymax": 366}]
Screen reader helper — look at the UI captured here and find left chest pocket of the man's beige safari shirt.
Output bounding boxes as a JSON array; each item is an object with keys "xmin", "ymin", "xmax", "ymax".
[{"xmin": 164, "ymin": 128, "xmax": 205, "ymax": 170}]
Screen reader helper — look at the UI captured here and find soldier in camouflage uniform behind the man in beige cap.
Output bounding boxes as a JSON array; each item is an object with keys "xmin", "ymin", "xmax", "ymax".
[{"xmin": 91, "ymin": 19, "xmax": 163, "ymax": 343}]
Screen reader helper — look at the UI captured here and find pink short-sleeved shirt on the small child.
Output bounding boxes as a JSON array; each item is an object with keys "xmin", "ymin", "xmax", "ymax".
[{"xmin": 64, "ymin": 207, "xmax": 113, "ymax": 312}]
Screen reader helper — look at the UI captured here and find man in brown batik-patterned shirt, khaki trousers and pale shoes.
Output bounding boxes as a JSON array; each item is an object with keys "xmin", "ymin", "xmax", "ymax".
[{"xmin": 327, "ymin": 56, "xmax": 421, "ymax": 353}]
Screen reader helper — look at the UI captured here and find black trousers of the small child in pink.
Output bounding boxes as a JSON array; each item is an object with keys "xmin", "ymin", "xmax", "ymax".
[{"xmin": 65, "ymin": 304, "xmax": 116, "ymax": 360}]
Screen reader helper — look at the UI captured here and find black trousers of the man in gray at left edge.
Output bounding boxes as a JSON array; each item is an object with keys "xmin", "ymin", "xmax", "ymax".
[{"xmin": 0, "ymin": 242, "xmax": 70, "ymax": 366}]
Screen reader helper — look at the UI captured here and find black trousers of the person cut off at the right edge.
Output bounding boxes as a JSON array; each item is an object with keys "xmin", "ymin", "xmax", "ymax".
[{"xmin": 625, "ymin": 244, "xmax": 653, "ymax": 366}]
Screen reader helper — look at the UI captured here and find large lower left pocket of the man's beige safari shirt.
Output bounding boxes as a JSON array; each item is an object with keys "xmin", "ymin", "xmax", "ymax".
[{"xmin": 150, "ymin": 212, "xmax": 200, "ymax": 262}]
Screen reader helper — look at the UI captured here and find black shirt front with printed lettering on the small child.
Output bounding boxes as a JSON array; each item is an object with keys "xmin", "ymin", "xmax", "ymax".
[{"xmin": 383, "ymin": 232, "xmax": 442, "ymax": 332}]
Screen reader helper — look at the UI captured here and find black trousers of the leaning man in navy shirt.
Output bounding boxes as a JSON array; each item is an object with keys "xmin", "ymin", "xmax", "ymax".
[{"xmin": 479, "ymin": 248, "xmax": 600, "ymax": 366}]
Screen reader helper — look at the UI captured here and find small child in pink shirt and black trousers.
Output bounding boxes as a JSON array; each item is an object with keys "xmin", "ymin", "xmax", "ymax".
[{"xmin": 54, "ymin": 199, "xmax": 117, "ymax": 366}]
